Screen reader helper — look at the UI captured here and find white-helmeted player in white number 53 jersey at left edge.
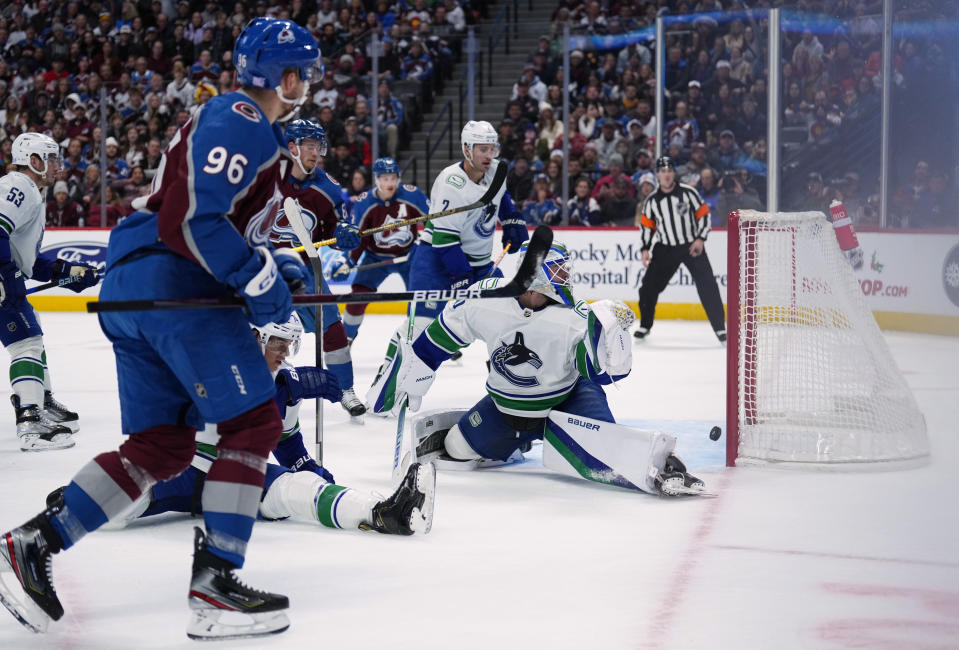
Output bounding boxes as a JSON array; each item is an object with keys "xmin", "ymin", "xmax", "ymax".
[{"xmin": 0, "ymin": 133, "xmax": 99, "ymax": 451}]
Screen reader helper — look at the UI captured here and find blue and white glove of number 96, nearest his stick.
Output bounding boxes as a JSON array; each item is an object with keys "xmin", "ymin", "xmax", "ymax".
[{"xmin": 225, "ymin": 246, "xmax": 293, "ymax": 325}]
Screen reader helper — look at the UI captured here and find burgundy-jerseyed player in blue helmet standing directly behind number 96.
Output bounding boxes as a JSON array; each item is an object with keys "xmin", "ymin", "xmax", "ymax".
[{"xmin": 272, "ymin": 120, "xmax": 366, "ymax": 422}]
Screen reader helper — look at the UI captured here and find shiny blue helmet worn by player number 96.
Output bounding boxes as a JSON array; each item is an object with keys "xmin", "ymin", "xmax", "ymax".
[{"xmin": 233, "ymin": 18, "xmax": 323, "ymax": 107}]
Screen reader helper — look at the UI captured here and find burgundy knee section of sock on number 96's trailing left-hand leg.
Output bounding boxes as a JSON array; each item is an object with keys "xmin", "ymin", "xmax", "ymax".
[{"xmin": 119, "ymin": 425, "xmax": 196, "ymax": 478}]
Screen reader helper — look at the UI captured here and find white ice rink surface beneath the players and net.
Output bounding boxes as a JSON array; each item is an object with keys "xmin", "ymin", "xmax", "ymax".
[{"xmin": 0, "ymin": 314, "xmax": 959, "ymax": 650}]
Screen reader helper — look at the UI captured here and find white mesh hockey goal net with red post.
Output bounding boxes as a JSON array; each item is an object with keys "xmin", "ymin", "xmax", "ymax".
[{"xmin": 726, "ymin": 210, "xmax": 929, "ymax": 468}]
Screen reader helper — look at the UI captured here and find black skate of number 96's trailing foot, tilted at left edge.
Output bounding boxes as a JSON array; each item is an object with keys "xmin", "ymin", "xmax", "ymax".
[{"xmin": 0, "ymin": 509, "xmax": 63, "ymax": 633}]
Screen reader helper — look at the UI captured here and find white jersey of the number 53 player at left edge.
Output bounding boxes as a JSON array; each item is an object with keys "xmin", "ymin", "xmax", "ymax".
[{"xmin": 0, "ymin": 172, "xmax": 46, "ymax": 277}]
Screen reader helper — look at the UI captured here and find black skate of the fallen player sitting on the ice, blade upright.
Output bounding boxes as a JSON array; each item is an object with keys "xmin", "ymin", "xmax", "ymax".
[{"xmin": 360, "ymin": 463, "xmax": 436, "ymax": 535}]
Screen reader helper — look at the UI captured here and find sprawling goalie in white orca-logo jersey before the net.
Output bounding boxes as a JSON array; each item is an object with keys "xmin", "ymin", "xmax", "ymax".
[{"xmin": 373, "ymin": 242, "xmax": 705, "ymax": 496}]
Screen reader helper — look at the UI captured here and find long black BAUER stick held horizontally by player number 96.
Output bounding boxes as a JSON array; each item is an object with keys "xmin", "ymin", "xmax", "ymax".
[{"xmin": 87, "ymin": 225, "xmax": 553, "ymax": 314}]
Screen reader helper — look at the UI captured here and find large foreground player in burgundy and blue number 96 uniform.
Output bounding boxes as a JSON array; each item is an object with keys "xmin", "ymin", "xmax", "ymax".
[{"xmin": 0, "ymin": 18, "xmax": 321, "ymax": 639}]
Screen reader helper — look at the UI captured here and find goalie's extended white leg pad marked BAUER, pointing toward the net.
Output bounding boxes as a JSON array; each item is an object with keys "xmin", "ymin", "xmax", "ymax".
[{"xmin": 543, "ymin": 410, "xmax": 676, "ymax": 494}]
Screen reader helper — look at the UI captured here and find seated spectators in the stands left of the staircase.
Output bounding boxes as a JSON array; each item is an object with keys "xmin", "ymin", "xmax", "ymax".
[{"xmin": 0, "ymin": 0, "xmax": 487, "ymax": 227}]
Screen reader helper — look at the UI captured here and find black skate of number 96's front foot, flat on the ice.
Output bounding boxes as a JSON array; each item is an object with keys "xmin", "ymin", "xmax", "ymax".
[{"xmin": 186, "ymin": 528, "xmax": 290, "ymax": 641}]
